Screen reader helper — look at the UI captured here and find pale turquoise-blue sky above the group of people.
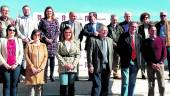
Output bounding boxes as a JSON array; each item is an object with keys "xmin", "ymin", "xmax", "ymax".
[{"xmin": 0, "ymin": 0, "xmax": 170, "ymax": 21}]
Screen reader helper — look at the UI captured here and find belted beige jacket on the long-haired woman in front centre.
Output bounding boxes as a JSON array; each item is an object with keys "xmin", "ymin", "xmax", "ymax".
[{"xmin": 57, "ymin": 40, "xmax": 80, "ymax": 73}]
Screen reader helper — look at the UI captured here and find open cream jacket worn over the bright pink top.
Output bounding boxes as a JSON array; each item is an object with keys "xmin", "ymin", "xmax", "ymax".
[{"xmin": 0, "ymin": 37, "xmax": 23, "ymax": 65}]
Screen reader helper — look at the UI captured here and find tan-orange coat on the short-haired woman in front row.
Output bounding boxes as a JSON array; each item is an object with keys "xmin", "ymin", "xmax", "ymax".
[{"xmin": 25, "ymin": 43, "xmax": 48, "ymax": 85}]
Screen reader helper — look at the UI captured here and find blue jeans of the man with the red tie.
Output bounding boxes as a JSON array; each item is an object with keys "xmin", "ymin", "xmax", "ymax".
[{"xmin": 121, "ymin": 61, "xmax": 138, "ymax": 96}]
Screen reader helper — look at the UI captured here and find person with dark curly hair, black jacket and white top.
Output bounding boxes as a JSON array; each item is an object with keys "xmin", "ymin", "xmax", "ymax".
[{"xmin": 138, "ymin": 12, "xmax": 150, "ymax": 79}]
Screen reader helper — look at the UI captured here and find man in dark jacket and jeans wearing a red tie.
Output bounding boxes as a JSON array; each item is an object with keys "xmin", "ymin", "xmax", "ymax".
[{"xmin": 117, "ymin": 22, "xmax": 142, "ymax": 96}]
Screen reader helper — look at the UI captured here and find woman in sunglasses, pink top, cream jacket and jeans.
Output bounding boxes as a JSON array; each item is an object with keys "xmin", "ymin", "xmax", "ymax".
[{"xmin": 0, "ymin": 25, "xmax": 23, "ymax": 96}]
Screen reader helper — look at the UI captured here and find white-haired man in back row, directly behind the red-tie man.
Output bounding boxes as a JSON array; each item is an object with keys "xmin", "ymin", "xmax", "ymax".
[{"xmin": 120, "ymin": 12, "xmax": 132, "ymax": 32}]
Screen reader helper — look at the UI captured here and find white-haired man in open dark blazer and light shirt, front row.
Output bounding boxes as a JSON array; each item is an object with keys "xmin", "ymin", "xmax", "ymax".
[{"xmin": 87, "ymin": 25, "xmax": 113, "ymax": 96}]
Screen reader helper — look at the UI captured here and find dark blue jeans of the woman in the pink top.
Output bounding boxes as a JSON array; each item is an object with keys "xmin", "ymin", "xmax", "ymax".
[{"xmin": 2, "ymin": 65, "xmax": 21, "ymax": 96}]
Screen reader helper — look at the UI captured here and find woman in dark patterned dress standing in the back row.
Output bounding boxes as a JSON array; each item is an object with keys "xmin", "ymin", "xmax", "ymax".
[{"xmin": 38, "ymin": 6, "xmax": 59, "ymax": 81}]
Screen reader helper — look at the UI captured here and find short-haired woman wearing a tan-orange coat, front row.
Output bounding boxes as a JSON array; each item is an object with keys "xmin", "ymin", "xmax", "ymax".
[{"xmin": 25, "ymin": 29, "xmax": 48, "ymax": 96}]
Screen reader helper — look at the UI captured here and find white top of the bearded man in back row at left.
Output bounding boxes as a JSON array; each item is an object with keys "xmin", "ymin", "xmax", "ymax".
[{"xmin": 16, "ymin": 16, "xmax": 38, "ymax": 39}]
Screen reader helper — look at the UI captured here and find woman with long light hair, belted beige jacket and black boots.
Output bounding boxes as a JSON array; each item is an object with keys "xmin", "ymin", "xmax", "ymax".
[{"xmin": 57, "ymin": 27, "xmax": 80, "ymax": 96}]
